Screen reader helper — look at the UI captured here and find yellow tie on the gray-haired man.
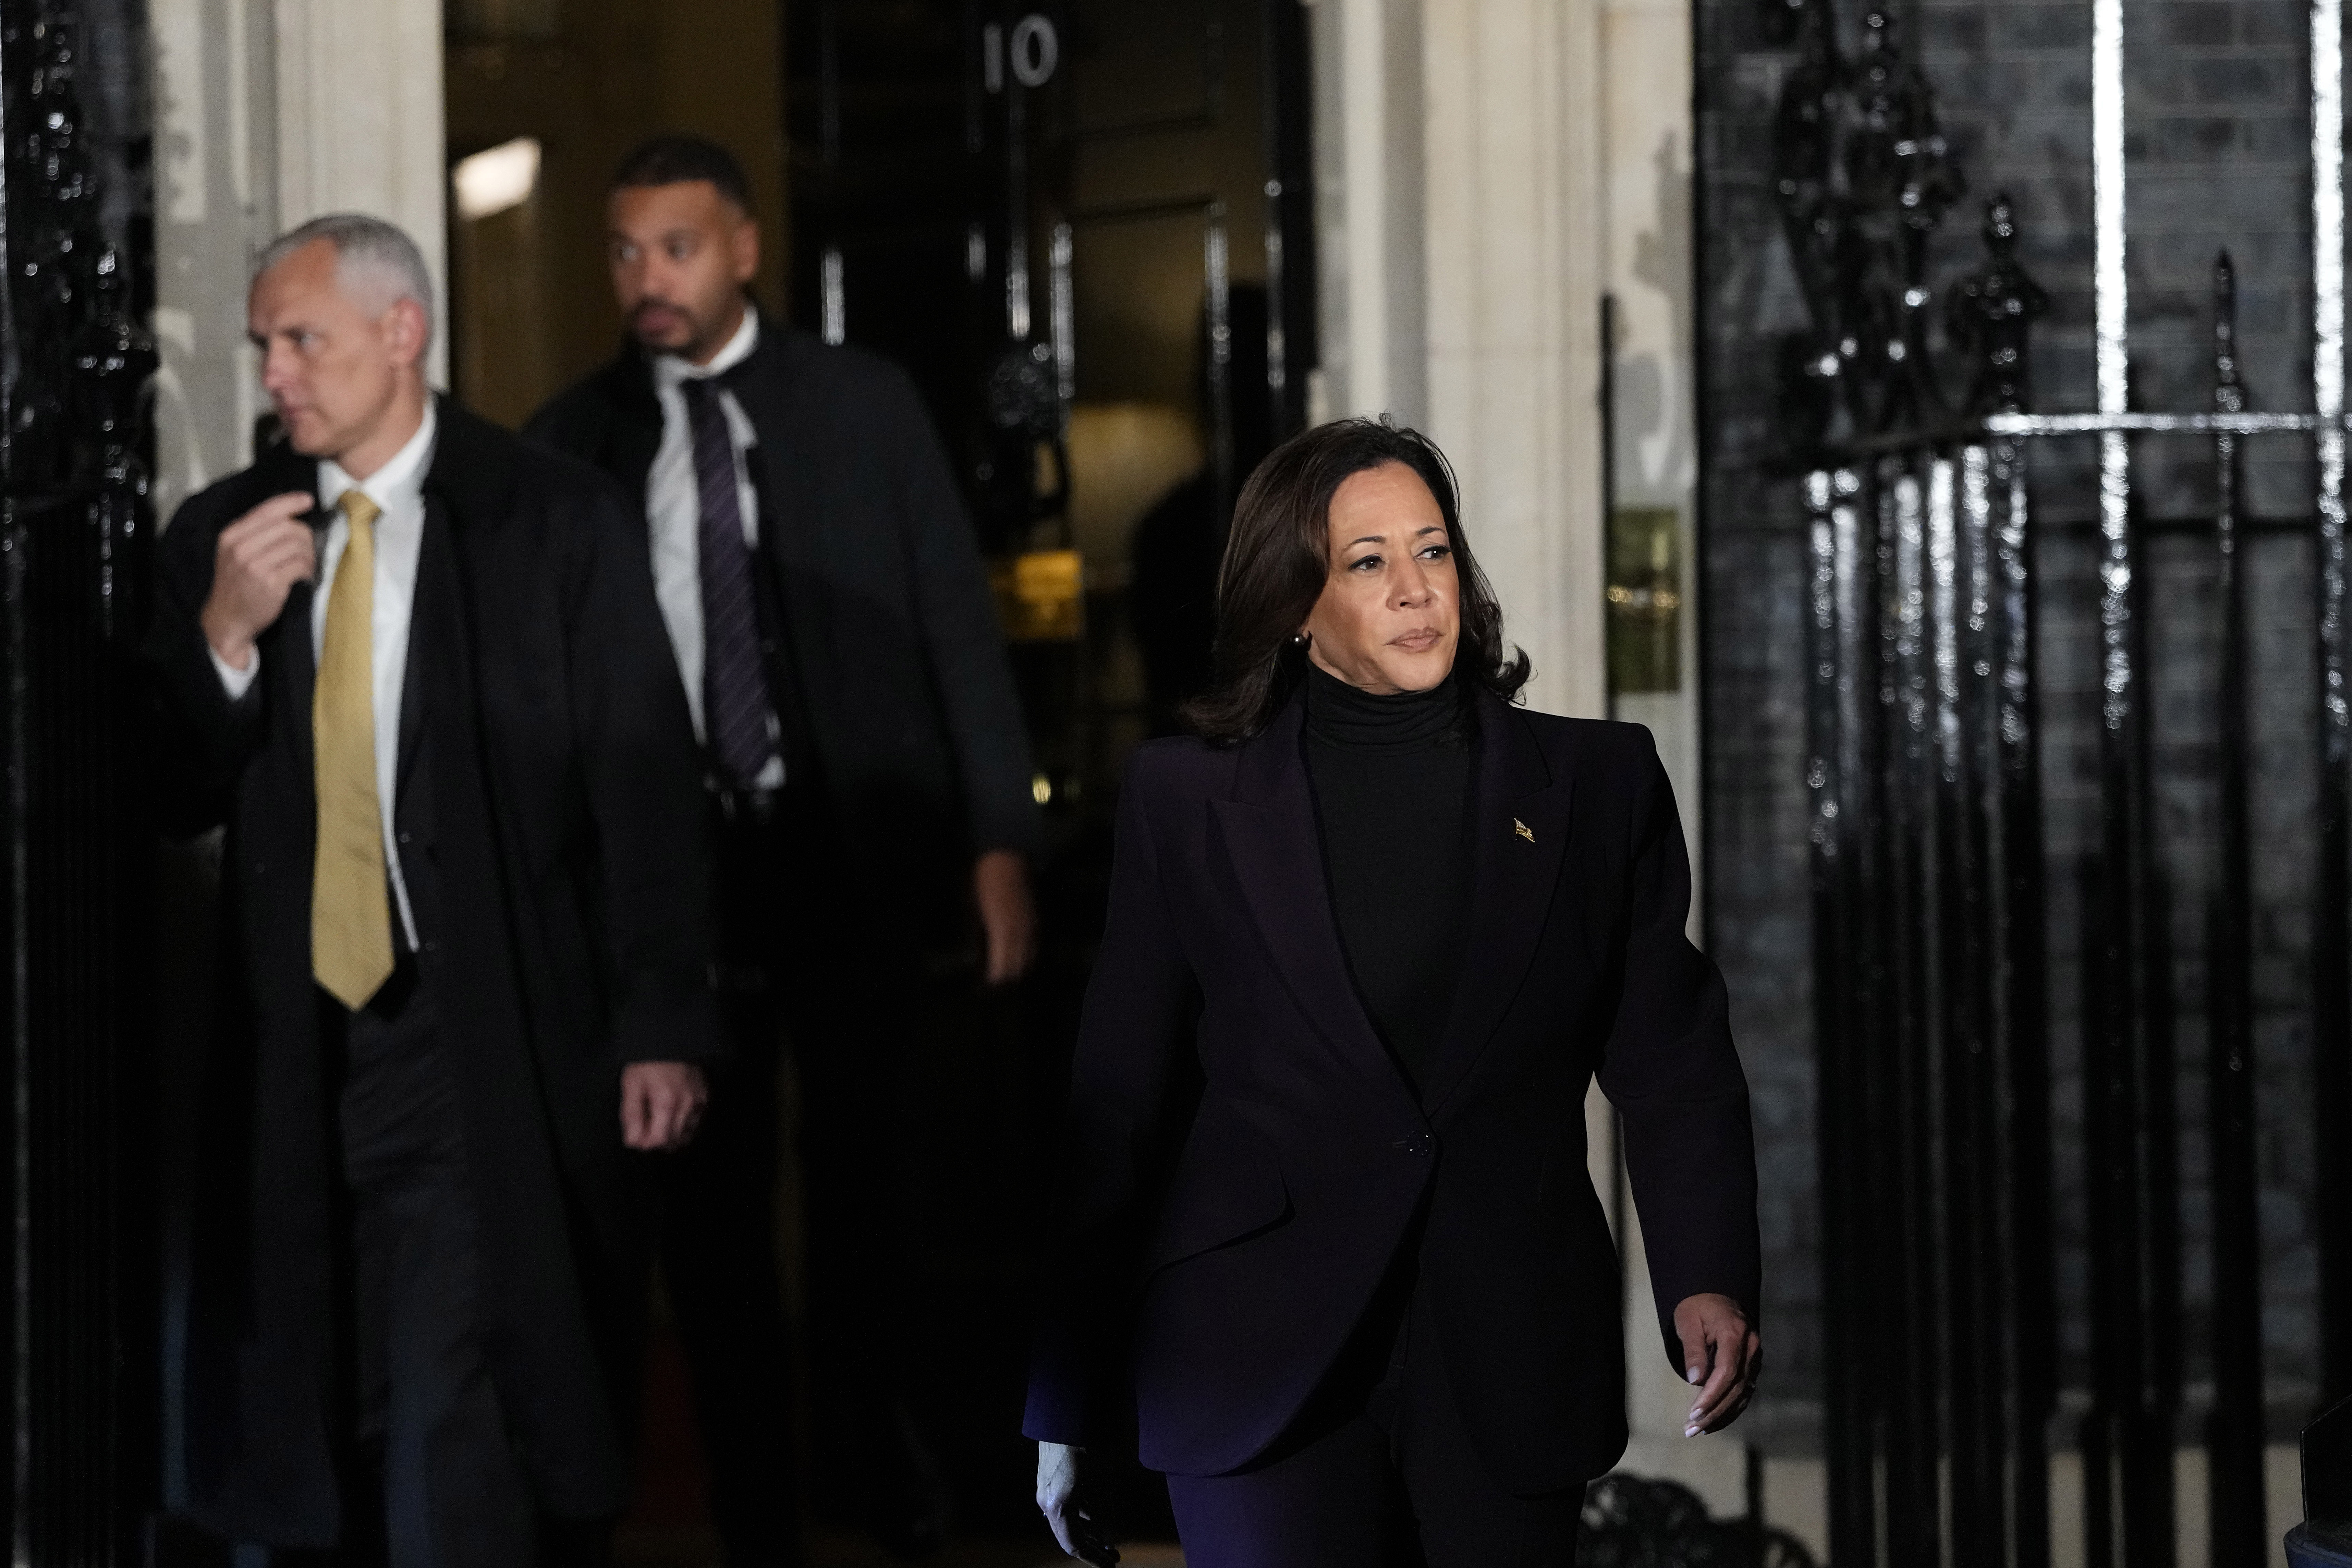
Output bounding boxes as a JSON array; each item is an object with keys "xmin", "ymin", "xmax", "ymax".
[{"xmin": 310, "ymin": 489, "xmax": 393, "ymax": 1011}]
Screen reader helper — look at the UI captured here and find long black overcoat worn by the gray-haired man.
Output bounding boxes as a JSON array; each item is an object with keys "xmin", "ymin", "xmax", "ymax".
[{"xmin": 146, "ymin": 402, "xmax": 717, "ymax": 1547}]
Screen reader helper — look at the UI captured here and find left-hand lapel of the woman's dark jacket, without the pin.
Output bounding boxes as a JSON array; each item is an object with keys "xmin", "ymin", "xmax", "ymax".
[{"xmin": 1209, "ymin": 698, "xmax": 1404, "ymax": 1089}]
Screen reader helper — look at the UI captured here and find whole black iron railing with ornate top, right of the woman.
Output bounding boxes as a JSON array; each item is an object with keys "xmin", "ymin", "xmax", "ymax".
[{"xmin": 1764, "ymin": 0, "xmax": 2352, "ymax": 1566}]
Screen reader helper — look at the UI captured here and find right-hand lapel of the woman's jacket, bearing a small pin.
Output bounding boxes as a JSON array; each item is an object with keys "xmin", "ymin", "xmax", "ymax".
[{"xmin": 1423, "ymin": 693, "xmax": 1573, "ymax": 1114}]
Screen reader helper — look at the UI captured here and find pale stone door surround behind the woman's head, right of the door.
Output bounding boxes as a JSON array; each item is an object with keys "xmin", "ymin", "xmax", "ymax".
[{"xmin": 1305, "ymin": 0, "xmax": 1701, "ymax": 785}]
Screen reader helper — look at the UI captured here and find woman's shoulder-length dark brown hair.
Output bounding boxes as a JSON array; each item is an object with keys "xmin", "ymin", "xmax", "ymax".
[{"xmin": 1183, "ymin": 418, "xmax": 1529, "ymax": 745}]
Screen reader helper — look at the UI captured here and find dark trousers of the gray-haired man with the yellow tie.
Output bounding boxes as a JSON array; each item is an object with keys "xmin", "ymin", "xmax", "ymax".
[{"xmin": 320, "ymin": 966, "xmax": 543, "ymax": 1568}]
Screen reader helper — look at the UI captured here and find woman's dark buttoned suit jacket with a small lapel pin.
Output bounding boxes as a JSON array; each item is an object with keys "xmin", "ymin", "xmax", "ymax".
[{"xmin": 1025, "ymin": 693, "xmax": 1757, "ymax": 1493}]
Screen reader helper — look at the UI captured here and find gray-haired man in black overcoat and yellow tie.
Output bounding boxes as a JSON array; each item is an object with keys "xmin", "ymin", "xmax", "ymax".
[{"xmin": 146, "ymin": 216, "xmax": 717, "ymax": 1568}]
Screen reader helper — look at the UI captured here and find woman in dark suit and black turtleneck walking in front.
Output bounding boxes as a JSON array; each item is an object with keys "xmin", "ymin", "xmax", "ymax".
[{"xmin": 1025, "ymin": 421, "xmax": 1762, "ymax": 1568}]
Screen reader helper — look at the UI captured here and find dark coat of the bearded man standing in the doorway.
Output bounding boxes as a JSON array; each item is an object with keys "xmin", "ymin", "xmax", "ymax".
[{"xmin": 524, "ymin": 317, "xmax": 1037, "ymax": 865}]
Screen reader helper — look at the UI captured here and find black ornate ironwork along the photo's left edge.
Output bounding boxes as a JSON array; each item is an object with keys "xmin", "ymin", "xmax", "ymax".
[{"xmin": 0, "ymin": 0, "xmax": 155, "ymax": 1568}]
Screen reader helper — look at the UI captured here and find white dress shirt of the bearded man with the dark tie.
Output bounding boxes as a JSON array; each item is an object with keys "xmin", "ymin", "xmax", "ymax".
[{"xmin": 644, "ymin": 308, "xmax": 783, "ymax": 790}]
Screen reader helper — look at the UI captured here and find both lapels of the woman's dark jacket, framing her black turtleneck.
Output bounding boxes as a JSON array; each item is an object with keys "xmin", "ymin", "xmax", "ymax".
[{"xmin": 1214, "ymin": 691, "xmax": 1573, "ymax": 1117}]
